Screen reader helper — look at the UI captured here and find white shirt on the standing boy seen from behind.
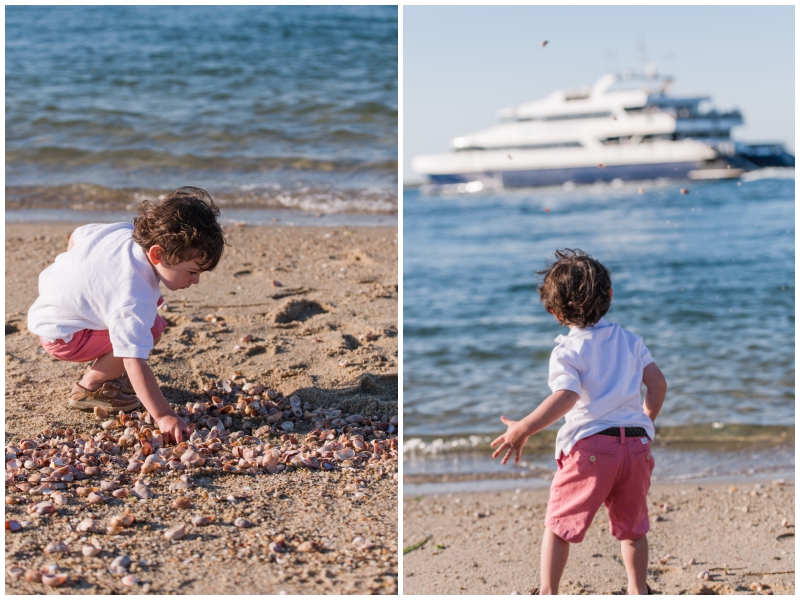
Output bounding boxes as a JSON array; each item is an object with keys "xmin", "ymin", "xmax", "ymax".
[{"xmin": 547, "ymin": 318, "xmax": 655, "ymax": 459}]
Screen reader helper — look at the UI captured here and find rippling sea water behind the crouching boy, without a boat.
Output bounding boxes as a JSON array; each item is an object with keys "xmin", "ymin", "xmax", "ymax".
[{"xmin": 5, "ymin": 6, "xmax": 398, "ymax": 214}]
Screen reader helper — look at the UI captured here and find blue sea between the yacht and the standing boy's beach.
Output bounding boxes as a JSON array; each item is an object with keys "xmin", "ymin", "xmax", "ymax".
[{"xmin": 403, "ymin": 177, "xmax": 795, "ymax": 488}]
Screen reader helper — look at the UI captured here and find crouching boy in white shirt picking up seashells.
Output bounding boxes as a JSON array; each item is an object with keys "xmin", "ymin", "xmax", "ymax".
[{"xmin": 28, "ymin": 187, "xmax": 225, "ymax": 443}]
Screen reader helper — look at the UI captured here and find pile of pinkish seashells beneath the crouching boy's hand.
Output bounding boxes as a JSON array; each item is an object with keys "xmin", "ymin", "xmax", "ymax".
[{"xmin": 5, "ymin": 380, "xmax": 398, "ymax": 586}]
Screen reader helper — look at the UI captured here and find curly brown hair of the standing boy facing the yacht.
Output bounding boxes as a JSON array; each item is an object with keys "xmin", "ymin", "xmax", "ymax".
[{"xmin": 536, "ymin": 248, "xmax": 611, "ymax": 328}]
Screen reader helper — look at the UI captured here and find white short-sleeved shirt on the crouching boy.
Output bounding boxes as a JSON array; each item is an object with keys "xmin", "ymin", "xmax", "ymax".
[{"xmin": 28, "ymin": 223, "xmax": 161, "ymax": 358}]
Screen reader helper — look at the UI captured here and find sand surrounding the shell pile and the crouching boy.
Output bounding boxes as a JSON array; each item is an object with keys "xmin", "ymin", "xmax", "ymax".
[{"xmin": 5, "ymin": 221, "xmax": 398, "ymax": 594}]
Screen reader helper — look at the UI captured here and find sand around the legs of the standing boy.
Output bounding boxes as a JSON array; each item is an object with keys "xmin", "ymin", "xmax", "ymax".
[{"xmin": 403, "ymin": 479, "xmax": 795, "ymax": 595}]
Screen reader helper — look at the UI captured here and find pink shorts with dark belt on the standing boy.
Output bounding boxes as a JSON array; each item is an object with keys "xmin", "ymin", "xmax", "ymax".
[{"xmin": 545, "ymin": 431, "xmax": 655, "ymax": 543}]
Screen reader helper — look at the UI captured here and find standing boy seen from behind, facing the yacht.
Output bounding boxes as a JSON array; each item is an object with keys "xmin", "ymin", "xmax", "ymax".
[{"xmin": 492, "ymin": 248, "xmax": 667, "ymax": 595}]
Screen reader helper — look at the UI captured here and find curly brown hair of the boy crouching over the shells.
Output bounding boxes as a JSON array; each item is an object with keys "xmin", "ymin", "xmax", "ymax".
[{"xmin": 133, "ymin": 186, "xmax": 227, "ymax": 271}]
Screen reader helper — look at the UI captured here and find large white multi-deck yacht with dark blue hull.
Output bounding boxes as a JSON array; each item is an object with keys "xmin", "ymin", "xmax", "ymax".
[{"xmin": 412, "ymin": 72, "xmax": 794, "ymax": 191}]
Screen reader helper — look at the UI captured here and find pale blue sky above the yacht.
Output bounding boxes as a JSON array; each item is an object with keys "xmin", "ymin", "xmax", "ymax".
[{"xmin": 402, "ymin": 6, "xmax": 795, "ymax": 183}]
